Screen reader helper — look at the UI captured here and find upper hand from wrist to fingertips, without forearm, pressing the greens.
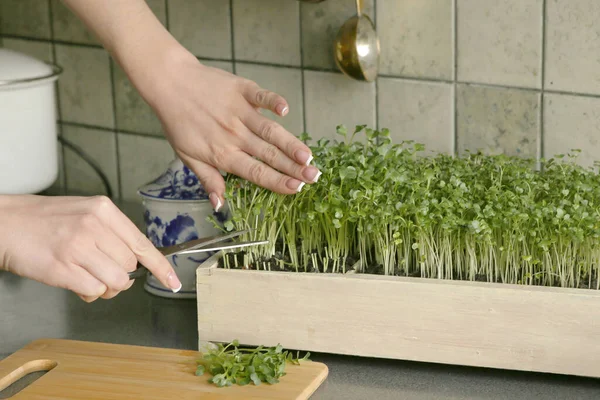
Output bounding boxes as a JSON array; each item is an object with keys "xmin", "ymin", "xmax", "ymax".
[{"xmin": 146, "ymin": 50, "xmax": 320, "ymax": 209}]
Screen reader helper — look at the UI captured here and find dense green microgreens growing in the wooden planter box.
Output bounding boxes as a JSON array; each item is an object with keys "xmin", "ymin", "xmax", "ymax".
[{"xmin": 211, "ymin": 125, "xmax": 600, "ymax": 289}]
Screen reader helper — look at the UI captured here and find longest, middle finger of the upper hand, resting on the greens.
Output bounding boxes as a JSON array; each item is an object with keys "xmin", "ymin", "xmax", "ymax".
[{"xmin": 244, "ymin": 132, "xmax": 321, "ymax": 183}]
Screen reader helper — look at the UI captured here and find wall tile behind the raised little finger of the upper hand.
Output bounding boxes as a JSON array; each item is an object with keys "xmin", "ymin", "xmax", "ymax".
[{"xmin": 236, "ymin": 63, "xmax": 304, "ymax": 135}]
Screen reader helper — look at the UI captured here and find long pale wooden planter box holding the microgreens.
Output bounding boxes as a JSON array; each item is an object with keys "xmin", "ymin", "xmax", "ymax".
[{"xmin": 197, "ymin": 254, "xmax": 600, "ymax": 377}]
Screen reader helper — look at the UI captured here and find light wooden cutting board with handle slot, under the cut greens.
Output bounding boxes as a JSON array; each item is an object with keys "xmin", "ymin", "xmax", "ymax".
[{"xmin": 0, "ymin": 339, "xmax": 328, "ymax": 400}]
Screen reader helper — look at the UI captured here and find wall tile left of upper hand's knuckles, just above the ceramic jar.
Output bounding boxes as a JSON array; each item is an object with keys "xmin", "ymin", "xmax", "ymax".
[{"xmin": 117, "ymin": 133, "xmax": 175, "ymax": 201}]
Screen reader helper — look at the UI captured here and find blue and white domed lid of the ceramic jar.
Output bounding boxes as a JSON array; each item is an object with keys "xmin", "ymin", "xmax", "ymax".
[{"xmin": 138, "ymin": 158, "xmax": 208, "ymax": 201}]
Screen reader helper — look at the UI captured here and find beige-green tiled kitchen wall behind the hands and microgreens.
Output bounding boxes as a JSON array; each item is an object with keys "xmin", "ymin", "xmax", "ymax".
[{"xmin": 0, "ymin": 0, "xmax": 600, "ymax": 199}]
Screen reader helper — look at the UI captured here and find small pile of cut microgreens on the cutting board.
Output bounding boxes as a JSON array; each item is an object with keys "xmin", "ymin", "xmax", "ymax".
[{"xmin": 196, "ymin": 340, "xmax": 310, "ymax": 387}]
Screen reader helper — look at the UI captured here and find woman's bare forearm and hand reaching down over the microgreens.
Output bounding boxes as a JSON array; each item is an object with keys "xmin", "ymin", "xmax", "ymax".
[{"xmin": 63, "ymin": 0, "xmax": 319, "ymax": 209}]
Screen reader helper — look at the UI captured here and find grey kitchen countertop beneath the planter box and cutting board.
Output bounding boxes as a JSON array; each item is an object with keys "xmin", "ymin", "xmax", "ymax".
[{"xmin": 0, "ymin": 198, "xmax": 600, "ymax": 400}]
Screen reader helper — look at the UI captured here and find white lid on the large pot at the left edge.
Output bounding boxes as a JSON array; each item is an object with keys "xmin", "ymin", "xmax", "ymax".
[{"xmin": 0, "ymin": 48, "xmax": 54, "ymax": 82}]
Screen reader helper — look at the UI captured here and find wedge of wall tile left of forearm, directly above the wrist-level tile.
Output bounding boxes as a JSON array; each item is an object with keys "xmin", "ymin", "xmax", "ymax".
[{"xmin": 112, "ymin": 61, "xmax": 163, "ymax": 135}]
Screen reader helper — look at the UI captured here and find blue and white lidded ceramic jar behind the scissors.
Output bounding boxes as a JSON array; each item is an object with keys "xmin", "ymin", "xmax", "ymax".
[{"xmin": 138, "ymin": 158, "xmax": 227, "ymax": 299}]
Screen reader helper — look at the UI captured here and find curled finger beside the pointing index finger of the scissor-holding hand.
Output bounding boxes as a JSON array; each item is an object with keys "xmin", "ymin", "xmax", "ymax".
[{"xmin": 79, "ymin": 248, "xmax": 130, "ymax": 298}]
